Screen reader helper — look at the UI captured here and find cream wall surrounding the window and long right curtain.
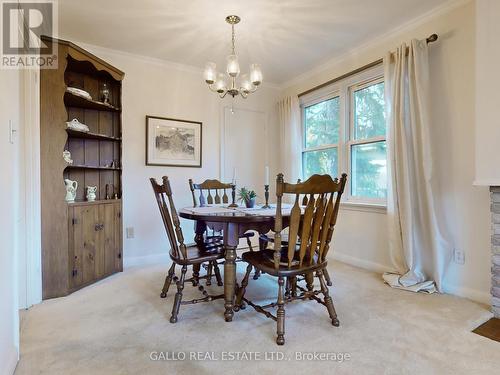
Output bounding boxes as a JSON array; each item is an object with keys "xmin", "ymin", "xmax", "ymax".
[{"xmin": 285, "ymin": 1, "xmax": 492, "ymax": 303}]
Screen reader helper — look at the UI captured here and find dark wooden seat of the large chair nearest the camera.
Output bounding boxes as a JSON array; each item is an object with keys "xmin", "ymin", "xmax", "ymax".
[{"xmin": 241, "ymin": 249, "xmax": 327, "ymax": 276}]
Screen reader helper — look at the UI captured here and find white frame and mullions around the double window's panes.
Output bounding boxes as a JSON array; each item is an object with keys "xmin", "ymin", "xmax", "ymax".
[{"xmin": 300, "ymin": 65, "xmax": 387, "ymax": 212}]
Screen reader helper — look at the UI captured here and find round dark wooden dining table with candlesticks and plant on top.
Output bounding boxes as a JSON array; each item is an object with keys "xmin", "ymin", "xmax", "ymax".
[{"xmin": 179, "ymin": 206, "xmax": 290, "ymax": 322}]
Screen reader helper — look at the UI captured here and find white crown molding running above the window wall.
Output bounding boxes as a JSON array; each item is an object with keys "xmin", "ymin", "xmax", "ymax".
[{"xmin": 281, "ymin": 0, "xmax": 474, "ymax": 90}]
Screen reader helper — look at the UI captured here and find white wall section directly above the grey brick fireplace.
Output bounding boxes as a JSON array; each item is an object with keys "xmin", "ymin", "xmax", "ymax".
[{"xmin": 475, "ymin": 0, "xmax": 500, "ymax": 186}]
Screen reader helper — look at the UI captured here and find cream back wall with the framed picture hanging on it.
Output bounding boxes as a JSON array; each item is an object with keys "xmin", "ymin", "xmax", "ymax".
[{"xmin": 76, "ymin": 42, "xmax": 279, "ymax": 265}]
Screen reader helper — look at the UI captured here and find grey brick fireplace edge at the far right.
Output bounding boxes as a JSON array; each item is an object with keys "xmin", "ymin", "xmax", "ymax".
[{"xmin": 490, "ymin": 186, "xmax": 500, "ymax": 318}]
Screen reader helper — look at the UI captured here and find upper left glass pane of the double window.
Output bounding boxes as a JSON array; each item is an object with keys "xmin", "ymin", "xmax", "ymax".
[{"xmin": 304, "ymin": 97, "xmax": 339, "ymax": 148}]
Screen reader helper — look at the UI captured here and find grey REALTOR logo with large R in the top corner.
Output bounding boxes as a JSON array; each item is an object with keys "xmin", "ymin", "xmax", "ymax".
[{"xmin": 0, "ymin": 0, "xmax": 57, "ymax": 69}]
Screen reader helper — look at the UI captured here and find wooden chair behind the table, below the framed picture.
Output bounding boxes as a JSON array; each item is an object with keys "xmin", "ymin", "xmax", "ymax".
[{"xmin": 189, "ymin": 178, "xmax": 259, "ymax": 285}]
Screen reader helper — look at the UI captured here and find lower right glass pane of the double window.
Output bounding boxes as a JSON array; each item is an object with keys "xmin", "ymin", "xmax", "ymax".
[{"xmin": 351, "ymin": 141, "xmax": 387, "ymax": 198}]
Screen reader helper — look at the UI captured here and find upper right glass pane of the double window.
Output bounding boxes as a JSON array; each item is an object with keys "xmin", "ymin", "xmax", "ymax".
[{"xmin": 353, "ymin": 82, "xmax": 386, "ymax": 139}]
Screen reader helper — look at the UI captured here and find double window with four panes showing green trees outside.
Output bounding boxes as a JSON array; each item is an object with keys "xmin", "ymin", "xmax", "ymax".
[{"xmin": 301, "ymin": 69, "xmax": 387, "ymax": 204}]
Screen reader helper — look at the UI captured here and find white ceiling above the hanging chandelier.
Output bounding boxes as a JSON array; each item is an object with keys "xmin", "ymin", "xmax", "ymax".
[{"xmin": 59, "ymin": 0, "xmax": 447, "ymax": 84}]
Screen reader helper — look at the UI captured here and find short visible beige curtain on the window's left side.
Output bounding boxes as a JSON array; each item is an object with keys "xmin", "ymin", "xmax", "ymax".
[{"xmin": 278, "ymin": 96, "xmax": 302, "ymax": 181}]
